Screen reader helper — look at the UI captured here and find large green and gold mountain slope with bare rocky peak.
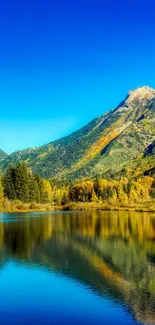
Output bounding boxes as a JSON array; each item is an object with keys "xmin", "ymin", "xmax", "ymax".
[{"xmin": 0, "ymin": 86, "xmax": 155, "ymax": 180}]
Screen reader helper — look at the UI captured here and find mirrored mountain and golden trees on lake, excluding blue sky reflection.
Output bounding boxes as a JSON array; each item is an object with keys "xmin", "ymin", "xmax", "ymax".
[{"xmin": 0, "ymin": 212, "xmax": 155, "ymax": 324}]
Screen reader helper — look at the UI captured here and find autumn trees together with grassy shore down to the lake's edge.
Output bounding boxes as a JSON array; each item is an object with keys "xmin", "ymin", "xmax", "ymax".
[{"xmin": 0, "ymin": 162, "xmax": 155, "ymax": 212}]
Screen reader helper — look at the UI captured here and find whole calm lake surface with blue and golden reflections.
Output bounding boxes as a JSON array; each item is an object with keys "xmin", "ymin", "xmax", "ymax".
[{"xmin": 0, "ymin": 212, "xmax": 155, "ymax": 325}]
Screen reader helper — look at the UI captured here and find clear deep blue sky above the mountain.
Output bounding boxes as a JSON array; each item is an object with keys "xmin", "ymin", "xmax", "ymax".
[{"xmin": 0, "ymin": 0, "xmax": 155, "ymax": 153}]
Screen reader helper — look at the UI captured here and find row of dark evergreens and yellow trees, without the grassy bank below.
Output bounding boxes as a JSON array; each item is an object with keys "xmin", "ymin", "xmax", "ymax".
[{"xmin": 0, "ymin": 162, "xmax": 155, "ymax": 206}]
